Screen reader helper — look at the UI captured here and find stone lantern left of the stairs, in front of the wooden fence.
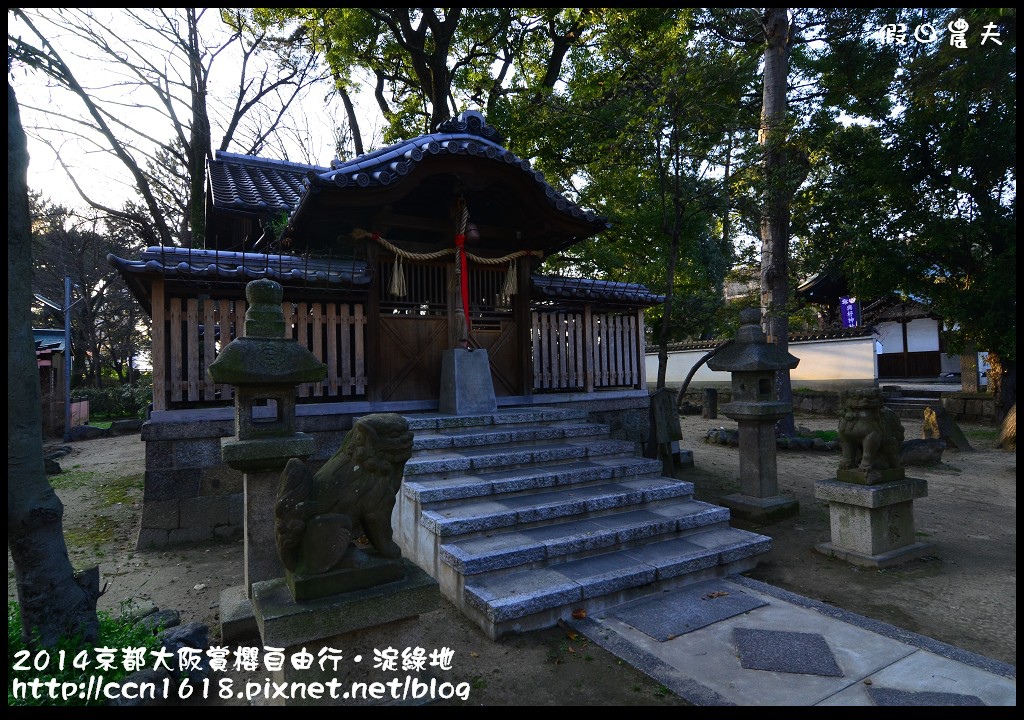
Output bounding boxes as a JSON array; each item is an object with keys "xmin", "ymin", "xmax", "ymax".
[{"xmin": 207, "ymin": 279, "xmax": 327, "ymax": 597}]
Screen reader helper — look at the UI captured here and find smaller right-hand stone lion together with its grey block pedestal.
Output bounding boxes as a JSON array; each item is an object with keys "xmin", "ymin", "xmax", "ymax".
[{"xmin": 814, "ymin": 388, "xmax": 932, "ymax": 567}]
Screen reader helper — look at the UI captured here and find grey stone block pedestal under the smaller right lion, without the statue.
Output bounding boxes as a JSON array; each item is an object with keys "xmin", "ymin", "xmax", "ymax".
[{"xmin": 814, "ymin": 477, "xmax": 932, "ymax": 567}]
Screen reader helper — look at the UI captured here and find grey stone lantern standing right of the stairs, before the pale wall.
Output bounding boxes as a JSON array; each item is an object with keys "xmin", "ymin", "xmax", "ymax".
[{"xmin": 708, "ymin": 307, "xmax": 800, "ymax": 520}]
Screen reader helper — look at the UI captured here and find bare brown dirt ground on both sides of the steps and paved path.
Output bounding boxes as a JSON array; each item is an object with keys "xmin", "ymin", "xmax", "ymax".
[{"xmin": 16, "ymin": 416, "xmax": 1017, "ymax": 706}]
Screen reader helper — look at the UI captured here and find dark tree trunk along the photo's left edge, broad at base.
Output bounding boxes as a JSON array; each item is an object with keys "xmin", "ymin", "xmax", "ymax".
[{"xmin": 7, "ymin": 81, "xmax": 99, "ymax": 647}]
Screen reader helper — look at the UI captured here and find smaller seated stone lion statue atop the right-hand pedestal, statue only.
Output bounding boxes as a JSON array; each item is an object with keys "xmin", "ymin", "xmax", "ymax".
[{"xmin": 839, "ymin": 388, "xmax": 903, "ymax": 471}]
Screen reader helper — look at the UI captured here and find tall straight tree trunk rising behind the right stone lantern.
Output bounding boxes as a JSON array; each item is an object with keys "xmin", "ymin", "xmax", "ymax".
[{"xmin": 758, "ymin": 7, "xmax": 796, "ymax": 435}]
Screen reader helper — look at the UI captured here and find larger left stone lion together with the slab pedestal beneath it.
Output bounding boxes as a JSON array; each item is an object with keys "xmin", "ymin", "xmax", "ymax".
[{"xmin": 252, "ymin": 413, "xmax": 440, "ymax": 683}]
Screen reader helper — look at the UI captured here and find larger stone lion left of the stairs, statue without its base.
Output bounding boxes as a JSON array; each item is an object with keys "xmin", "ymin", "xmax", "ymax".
[{"xmin": 274, "ymin": 413, "xmax": 413, "ymax": 576}]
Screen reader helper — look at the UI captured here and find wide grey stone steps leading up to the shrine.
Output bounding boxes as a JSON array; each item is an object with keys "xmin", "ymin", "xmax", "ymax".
[{"xmin": 393, "ymin": 408, "xmax": 771, "ymax": 639}]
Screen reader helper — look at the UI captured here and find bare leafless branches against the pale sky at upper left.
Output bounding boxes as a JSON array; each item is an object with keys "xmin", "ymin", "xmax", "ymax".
[{"xmin": 7, "ymin": 8, "xmax": 321, "ymax": 247}]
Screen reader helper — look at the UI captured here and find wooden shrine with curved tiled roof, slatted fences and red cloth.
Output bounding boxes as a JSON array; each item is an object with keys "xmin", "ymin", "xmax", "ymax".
[{"xmin": 109, "ymin": 112, "xmax": 664, "ymax": 546}]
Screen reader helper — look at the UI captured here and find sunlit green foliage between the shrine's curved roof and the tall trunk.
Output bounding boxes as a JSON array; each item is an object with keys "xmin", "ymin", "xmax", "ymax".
[{"xmin": 535, "ymin": 8, "xmax": 756, "ymax": 358}]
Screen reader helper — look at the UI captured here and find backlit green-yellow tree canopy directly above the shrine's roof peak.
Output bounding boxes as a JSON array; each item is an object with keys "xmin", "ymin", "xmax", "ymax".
[{"xmin": 254, "ymin": 7, "xmax": 599, "ymax": 145}]
